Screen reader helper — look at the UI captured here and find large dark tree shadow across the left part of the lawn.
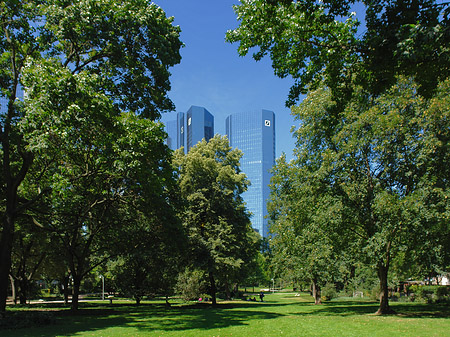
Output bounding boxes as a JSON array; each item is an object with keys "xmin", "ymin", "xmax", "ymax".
[{"xmin": 0, "ymin": 302, "xmax": 286, "ymax": 337}]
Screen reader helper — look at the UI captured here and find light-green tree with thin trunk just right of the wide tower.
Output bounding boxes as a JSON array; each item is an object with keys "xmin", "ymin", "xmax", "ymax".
[{"xmin": 268, "ymin": 155, "xmax": 349, "ymax": 304}]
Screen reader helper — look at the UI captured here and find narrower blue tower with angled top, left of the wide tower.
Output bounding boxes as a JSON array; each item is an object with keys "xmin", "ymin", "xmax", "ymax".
[{"xmin": 186, "ymin": 105, "xmax": 214, "ymax": 152}]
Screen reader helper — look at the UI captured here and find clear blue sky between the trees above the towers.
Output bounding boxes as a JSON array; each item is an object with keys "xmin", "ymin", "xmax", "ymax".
[{"xmin": 154, "ymin": 0, "xmax": 295, "ymax": 159}]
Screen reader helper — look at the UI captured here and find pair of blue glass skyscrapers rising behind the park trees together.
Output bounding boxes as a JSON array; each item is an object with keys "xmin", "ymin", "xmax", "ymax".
[{"xmin": 165, "ymin": 106, "xmax": 275, "ymax": 237}]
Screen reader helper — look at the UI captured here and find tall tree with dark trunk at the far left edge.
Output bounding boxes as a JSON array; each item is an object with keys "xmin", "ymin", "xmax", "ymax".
[{"xmin": 0, "ymin": 0, "xmax": 181, "ymax": 315}]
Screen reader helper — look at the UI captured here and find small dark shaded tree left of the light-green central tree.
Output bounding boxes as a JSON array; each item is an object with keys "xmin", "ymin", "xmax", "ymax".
[{"xmin": 108, "ymin": 203, "xmax": 187, "ymax": 304}]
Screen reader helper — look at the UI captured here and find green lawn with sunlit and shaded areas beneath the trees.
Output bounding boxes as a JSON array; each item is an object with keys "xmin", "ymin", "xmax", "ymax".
[{"xmin": 0, "ymin": 293, "xmax": 450, "ymax": 337}]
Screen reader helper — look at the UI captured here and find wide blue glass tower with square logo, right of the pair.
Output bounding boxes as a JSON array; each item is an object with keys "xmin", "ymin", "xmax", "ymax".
[{"xmin": 226, "ymin": 110, "xmax": 275, "ymax": 237}]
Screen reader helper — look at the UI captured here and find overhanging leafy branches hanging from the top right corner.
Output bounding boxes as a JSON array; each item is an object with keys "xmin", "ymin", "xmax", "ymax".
[{"xmin": 226, "ymin": 0, "xmax": 450, "ymax": 105}]
